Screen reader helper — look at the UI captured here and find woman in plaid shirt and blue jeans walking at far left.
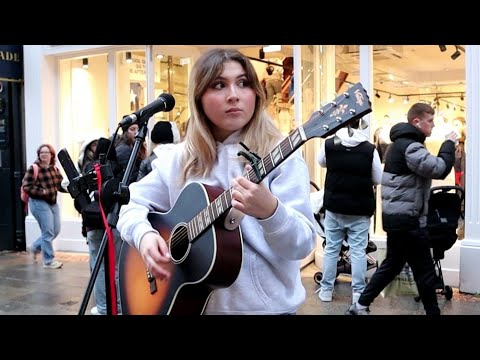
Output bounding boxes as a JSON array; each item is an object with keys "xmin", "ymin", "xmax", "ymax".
[{"xmin": 22, "ymin": 144, "xmax": 67, "ymax": 269}]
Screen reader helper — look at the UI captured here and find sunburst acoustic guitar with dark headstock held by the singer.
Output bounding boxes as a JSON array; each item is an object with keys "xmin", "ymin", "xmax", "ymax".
[{"xmin": 119, "ymin": 83, "xmax": 372, "ymax": 315}]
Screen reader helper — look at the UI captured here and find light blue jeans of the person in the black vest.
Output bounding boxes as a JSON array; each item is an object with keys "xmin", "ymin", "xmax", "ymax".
[{"xmin": 320, "ymin": 210, "xmax": 370, "ymax": 293}]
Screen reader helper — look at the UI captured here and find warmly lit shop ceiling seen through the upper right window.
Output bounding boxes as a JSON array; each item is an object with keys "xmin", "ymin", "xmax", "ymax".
[{"xmin": 336, "ymin": 45, "xmax": 465, "ymax": 95}]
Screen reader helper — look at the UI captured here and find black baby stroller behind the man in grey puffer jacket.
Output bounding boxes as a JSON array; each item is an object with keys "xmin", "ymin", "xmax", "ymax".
[{"xmin": 415, "ymin": 186, "xmax": 465, "ymax": 301}]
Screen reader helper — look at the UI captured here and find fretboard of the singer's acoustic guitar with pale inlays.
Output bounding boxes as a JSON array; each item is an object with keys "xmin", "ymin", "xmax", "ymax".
[{"xmin": 187, "ymin": 126, "xmax": 307, "ymax": 239}]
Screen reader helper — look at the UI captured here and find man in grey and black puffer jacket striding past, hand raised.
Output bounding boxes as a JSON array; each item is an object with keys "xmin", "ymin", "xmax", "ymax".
[{"xmin": 346, "ymin": 103, "xmax": 457, "ymax": 315}]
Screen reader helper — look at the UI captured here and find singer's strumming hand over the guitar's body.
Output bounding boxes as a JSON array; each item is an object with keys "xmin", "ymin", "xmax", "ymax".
[{"xmin": 140, "ymin": 232, "xmax": 171, "ymax": 280}]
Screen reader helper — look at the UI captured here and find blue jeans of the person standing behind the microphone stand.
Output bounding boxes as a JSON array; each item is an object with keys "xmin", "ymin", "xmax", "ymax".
[{"xmin": 87, "ymin": 229, "xmax": 122, "ymax": 315}]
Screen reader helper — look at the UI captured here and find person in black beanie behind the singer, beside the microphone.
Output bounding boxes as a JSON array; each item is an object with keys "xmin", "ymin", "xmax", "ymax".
[{"xmin": 137, "ymin": 121, "xmax": 180, "ymax": 181}]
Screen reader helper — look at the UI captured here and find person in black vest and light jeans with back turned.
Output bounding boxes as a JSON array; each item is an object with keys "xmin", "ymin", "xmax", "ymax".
[{"xmin": 318, "ymin": 120, "xmax": 382, "ymax": 303}]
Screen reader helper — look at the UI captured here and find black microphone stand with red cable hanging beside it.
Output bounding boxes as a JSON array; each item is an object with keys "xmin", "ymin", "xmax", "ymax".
[{"xmin": 78, "ymin": 121, "xmax": 147, "ymax": 315}]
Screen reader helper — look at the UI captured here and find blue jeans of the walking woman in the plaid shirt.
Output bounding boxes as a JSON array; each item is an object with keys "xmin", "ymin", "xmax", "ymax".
[{"xmin": 28, "ymin": 198, "xmax": 60, "ymax": 264}]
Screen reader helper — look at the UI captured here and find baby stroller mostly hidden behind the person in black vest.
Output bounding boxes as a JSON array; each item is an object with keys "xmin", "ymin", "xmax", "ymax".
[{"xmin": 310, "ymin": 181, "xmax": 378, "ymax": 284}]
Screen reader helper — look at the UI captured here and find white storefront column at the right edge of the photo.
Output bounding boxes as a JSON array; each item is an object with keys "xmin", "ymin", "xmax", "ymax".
[{"xmin": 460, "ymin": 45, "xmax": 480, "ymax": 294}]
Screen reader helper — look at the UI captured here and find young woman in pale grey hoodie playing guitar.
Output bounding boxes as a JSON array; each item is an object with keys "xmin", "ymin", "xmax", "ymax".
[{"xmin": 117, "ymin": 49, "xmax": 315, "ymax": 314}]
